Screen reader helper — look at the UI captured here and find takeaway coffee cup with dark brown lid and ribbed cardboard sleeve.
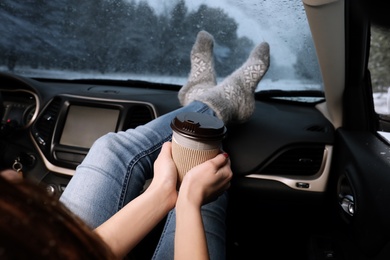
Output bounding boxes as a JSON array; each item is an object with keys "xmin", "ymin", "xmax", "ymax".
[{"xmin": 171, "ymin": 112, "xmax": 226, "ymax": 183}]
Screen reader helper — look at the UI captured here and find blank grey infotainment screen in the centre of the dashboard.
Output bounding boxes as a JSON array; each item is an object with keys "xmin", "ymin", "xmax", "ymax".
[{"xmin": 60, "ymin": 105, "xmax": 119, "ymax": 148}]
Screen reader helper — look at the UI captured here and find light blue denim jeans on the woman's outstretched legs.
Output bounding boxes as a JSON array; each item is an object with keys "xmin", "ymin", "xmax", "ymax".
[{"xmin": 60, "ymin": 101, "xmax": 227, "ymax": 259}]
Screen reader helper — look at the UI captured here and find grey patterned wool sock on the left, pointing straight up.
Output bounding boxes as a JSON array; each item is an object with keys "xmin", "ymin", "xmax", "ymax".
[{"xmin": 178, "ymin": 31, "xmax": 217, "ymax": 106}]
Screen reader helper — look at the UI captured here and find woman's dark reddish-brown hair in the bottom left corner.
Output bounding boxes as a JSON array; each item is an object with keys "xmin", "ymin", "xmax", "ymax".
[{"xmin": 0, "ymin": 177, "xmax": 115, "ymax": 259}]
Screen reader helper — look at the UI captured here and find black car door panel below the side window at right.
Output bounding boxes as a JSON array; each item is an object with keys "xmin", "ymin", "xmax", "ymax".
[{"xmin": 331, "ymin": 129, "xmax": 390, "ymax": 259}]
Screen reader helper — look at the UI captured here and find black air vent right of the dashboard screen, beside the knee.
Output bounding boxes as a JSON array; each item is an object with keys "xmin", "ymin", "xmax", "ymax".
[{"xmin": 125, "ymin": 105, "xmax": 154, "ymax": 129}]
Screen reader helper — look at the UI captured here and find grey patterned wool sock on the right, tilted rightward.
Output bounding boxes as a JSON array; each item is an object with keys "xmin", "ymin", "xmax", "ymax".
[{"xmin": 194, "ymin": 42, "xmax": 269, "ymax": 124}]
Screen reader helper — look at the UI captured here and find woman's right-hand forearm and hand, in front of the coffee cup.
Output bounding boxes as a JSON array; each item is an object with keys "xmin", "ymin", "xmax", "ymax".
[{"xmin": 175, "ymin": 153, "xmax": 233, "ymax": 260}]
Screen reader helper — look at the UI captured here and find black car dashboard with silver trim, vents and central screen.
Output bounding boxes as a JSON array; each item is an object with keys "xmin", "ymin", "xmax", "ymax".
[{"xmin": 0, "ymin": 73, "xmax": 334, "ymax": 195}]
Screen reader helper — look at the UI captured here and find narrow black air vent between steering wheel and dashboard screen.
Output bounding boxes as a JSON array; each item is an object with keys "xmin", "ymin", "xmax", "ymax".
[{"xmin": 33, "ymin": 98, "xmax": 61, "ymax": 148}]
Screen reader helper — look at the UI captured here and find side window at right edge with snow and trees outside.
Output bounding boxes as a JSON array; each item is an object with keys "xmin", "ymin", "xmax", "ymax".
[{"xmin": 368, "ymin": 25, "xmax": 390, "ymax": 117}]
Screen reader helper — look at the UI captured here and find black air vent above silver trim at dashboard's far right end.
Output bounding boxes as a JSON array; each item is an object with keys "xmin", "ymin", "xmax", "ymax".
[{"xmin": 260, "ymin": 145, "xmax": 325, "ymax": 176}]
